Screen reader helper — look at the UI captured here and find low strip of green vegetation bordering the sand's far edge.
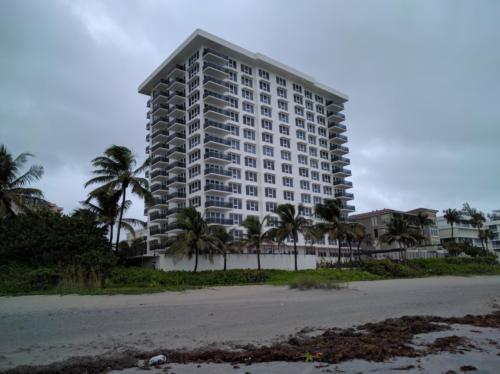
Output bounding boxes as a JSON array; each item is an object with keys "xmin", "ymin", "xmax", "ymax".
[{"xmin": 0, "ymin": 257, "xmax": 500, "ymax": 295}]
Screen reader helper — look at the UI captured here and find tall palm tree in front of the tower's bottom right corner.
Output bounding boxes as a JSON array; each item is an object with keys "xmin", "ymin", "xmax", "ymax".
[{"xmin": 314, "ymin": 199, "xmax": 347, "ymax": 266}]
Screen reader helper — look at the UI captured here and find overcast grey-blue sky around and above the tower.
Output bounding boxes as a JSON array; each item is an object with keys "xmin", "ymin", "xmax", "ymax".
[{"xmin": 0, "ymin": 0, "xmax": 500, "ymax": 217}]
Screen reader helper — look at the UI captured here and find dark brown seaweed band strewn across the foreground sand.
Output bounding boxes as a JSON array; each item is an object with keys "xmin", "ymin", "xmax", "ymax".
[{"xmin": 5, "ymin": 312, "xmax": 500, "ymax": 374}]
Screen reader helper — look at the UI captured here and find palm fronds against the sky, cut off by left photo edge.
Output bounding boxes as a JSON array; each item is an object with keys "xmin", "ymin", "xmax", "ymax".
[{"xmin": 0, "ymin": 144, "xmax": 46, "ymax": 218}]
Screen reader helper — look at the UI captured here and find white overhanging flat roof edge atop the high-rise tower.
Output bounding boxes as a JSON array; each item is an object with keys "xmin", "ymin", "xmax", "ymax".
[{"xmin": 138, "ymin": 29, "xmax": 349, "ymax": 102}]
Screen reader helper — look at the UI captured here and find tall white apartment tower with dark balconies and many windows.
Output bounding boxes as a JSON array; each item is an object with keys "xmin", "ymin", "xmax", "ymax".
[{"xmin": 139, "ymin": 30, "xmax": 354, "ymax": 252}]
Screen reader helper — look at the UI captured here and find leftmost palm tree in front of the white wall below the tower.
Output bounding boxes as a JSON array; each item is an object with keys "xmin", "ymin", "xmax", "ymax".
[{"xmin": 167, "ymin": 207, "xmax": 217, "ymax": 273}]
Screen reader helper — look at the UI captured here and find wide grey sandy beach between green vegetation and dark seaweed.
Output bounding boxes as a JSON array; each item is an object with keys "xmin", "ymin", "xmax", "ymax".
[{"xmin": 0, "ymin": 277, "xmax": 500, "ymax": 372}]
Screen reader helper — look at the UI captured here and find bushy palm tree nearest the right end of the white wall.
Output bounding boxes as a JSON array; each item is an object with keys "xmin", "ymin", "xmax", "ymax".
[{"xmin": 269, "ymin": 204, "xmax": 311, "ymax": 271}]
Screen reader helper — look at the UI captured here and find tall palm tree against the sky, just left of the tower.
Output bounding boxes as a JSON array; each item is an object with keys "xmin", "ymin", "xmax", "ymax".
[{"xmin": 85, "ymin": 145, "xmax": 151, "ymax": 247}]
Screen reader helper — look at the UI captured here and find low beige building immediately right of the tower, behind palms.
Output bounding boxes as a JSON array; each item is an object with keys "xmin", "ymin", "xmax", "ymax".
[{"xmin": 351, "ymin": 208, "xmax": 440, "ymax": 250}]
